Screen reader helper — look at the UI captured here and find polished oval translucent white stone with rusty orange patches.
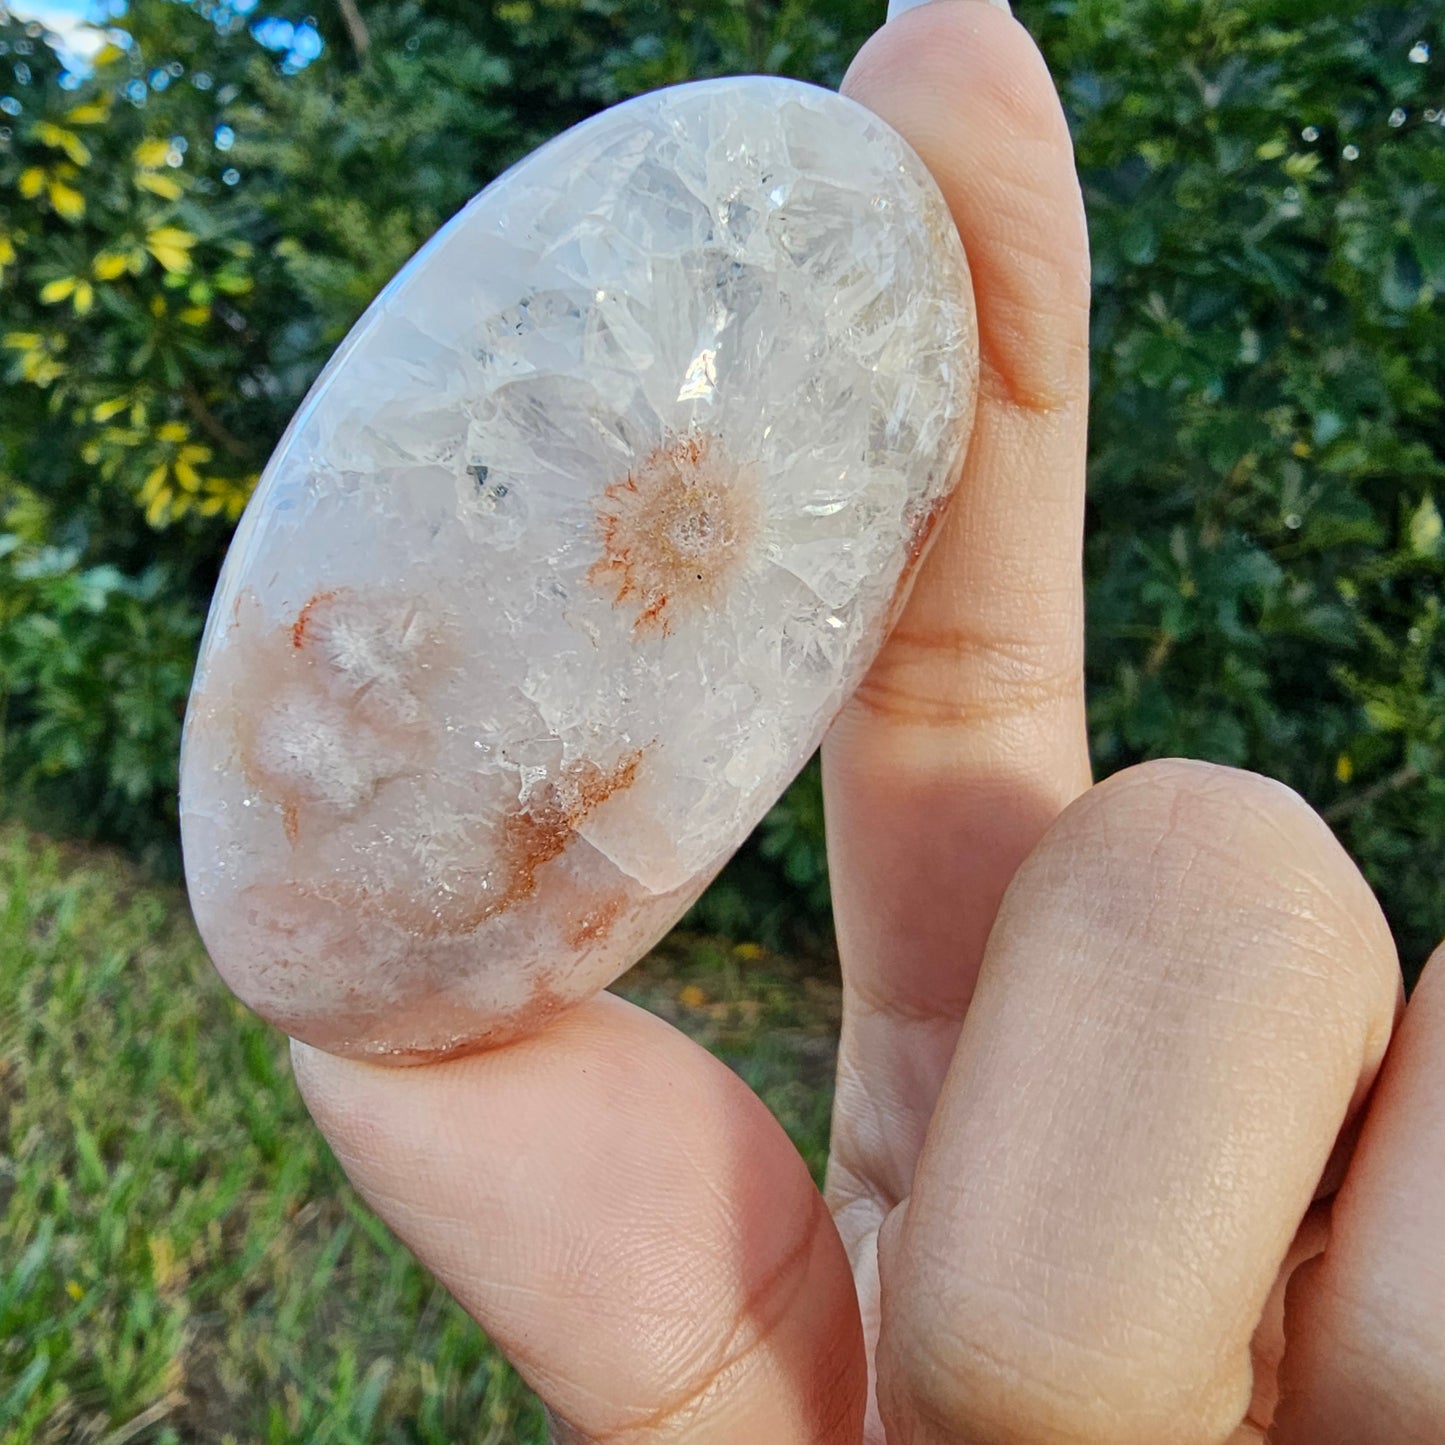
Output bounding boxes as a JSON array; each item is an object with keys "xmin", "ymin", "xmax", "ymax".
[{"xmin": 181, "ymin": 78, "xmax": 977, "ymax": 1062}]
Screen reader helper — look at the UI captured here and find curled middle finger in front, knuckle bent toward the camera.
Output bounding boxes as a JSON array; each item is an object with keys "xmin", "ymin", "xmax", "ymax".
[{"xmin": 879, "ymin": 762, "xmax": 1399, "ymax": 1445}]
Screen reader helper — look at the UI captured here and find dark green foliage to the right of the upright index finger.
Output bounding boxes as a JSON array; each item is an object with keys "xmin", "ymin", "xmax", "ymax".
[{"xmin": 1049, "ymin": 0, "xmax": 1445, "ymax": 961}]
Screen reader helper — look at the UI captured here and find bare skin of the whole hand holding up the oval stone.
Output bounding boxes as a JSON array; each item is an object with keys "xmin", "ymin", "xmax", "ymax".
[{"xmin": 295, "ymin": 0, "xmax": 1445, "ymax": 1445}]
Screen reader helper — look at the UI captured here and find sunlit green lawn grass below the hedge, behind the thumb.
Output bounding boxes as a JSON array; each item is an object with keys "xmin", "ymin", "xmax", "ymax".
[{"xmin": 0, "ymin": 828, "xmax": 838, "ymax": 1445}]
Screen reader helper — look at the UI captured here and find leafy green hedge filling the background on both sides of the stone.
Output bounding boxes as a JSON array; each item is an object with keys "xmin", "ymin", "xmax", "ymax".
[{"xmin": 0, "ymin": 0, "xmax": 1445, "ymax": 961}]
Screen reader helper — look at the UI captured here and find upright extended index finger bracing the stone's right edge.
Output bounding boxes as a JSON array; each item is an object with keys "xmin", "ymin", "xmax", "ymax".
[{"xmin": 824, "ymin": 0, "xmax": 1090, "ymax": 1238}]
